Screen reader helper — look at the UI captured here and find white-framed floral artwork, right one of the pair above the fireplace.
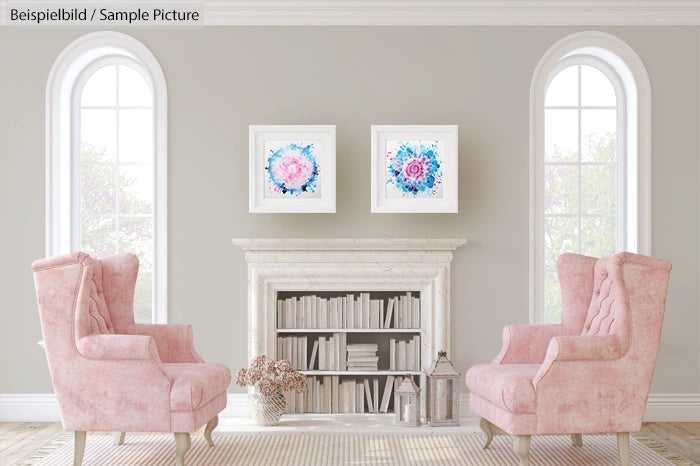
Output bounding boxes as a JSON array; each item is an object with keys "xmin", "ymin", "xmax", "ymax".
[{"xmin": 372, "ymin": 125, "xmax": 457, "ymax": 213}]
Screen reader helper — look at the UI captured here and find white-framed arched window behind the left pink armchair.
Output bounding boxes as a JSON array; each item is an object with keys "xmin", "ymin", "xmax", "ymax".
[{"xmin": 47, "ymin": 32, "xmax": 167, "ymax": 322}]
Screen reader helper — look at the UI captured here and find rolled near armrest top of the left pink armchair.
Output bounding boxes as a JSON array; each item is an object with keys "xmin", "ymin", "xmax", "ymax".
[{"xmin": 76, "ymin": 334, "xmax": 160, "ymax": 361}]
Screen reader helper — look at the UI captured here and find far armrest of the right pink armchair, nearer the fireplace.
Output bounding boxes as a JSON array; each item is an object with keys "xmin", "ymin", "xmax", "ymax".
[{"xmin": 491, "ymin": 324, "xmax": 564, "ymax": 364}]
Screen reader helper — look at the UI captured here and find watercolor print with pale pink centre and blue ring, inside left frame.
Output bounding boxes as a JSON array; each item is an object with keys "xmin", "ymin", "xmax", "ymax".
[{"xmin": 265, "ymin": 141, "xmax": 321, "ymax": 198}]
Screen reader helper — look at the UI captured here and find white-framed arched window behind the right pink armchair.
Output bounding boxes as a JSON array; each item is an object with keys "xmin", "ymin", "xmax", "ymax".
[{"xmin": 530, "ymin": 32, "xmax": 651, "ymax": 323}]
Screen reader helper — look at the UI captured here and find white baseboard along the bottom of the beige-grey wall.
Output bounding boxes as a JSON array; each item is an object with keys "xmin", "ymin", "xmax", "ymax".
[{"xmin": 0, "ymin": 393, "xmax": 700, "ymax": 422}]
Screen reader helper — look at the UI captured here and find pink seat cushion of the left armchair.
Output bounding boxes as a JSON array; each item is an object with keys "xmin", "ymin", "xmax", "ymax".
[{"xmin": 163, "ymin": 363, "xmax": 231, "ymax": 412}]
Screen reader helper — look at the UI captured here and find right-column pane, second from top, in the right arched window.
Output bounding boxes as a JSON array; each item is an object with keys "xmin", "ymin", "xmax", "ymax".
[{"xmin": 581, "ymin": 110, "xmax": 617, "ymax": 162}]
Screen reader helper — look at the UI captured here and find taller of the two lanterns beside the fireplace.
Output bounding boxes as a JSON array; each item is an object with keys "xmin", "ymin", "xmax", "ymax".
[{"xmin": 425, "ymin": 351, "xmax": 460, "ymax": 426}]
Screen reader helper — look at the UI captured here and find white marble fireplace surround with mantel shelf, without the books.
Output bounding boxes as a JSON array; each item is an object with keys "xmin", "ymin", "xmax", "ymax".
[{"xmin": 232, "ymin": 238, "xmax": 467, "ymax": 365}]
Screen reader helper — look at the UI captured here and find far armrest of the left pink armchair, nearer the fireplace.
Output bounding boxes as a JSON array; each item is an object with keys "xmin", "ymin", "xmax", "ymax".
[{"xmin": 131, "ymin": 324, "xmax": 204, "ymax": 362}]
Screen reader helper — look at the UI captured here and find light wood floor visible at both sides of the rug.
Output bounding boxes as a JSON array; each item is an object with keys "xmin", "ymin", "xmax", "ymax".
[{"xmin": 0, "ymin": 422, "xmax": 700, "ymax": 466}]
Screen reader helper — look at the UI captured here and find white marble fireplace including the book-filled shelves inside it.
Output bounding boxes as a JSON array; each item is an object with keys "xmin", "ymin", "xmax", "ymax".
[{"xmin": 233, "ymin": 239, "xmax": 466, "ymax": 424}]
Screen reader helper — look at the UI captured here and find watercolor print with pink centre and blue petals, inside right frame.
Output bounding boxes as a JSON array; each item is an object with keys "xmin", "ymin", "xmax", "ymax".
[{"xmin": 385, "ymin": 140, "xmax": 445, "ymax": 199}]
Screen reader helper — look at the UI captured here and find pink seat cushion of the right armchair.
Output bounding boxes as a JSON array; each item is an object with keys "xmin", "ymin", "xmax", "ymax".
[{"xmin": 466, "ymin": 364, "xmax": 540, "ymax": 413}]
